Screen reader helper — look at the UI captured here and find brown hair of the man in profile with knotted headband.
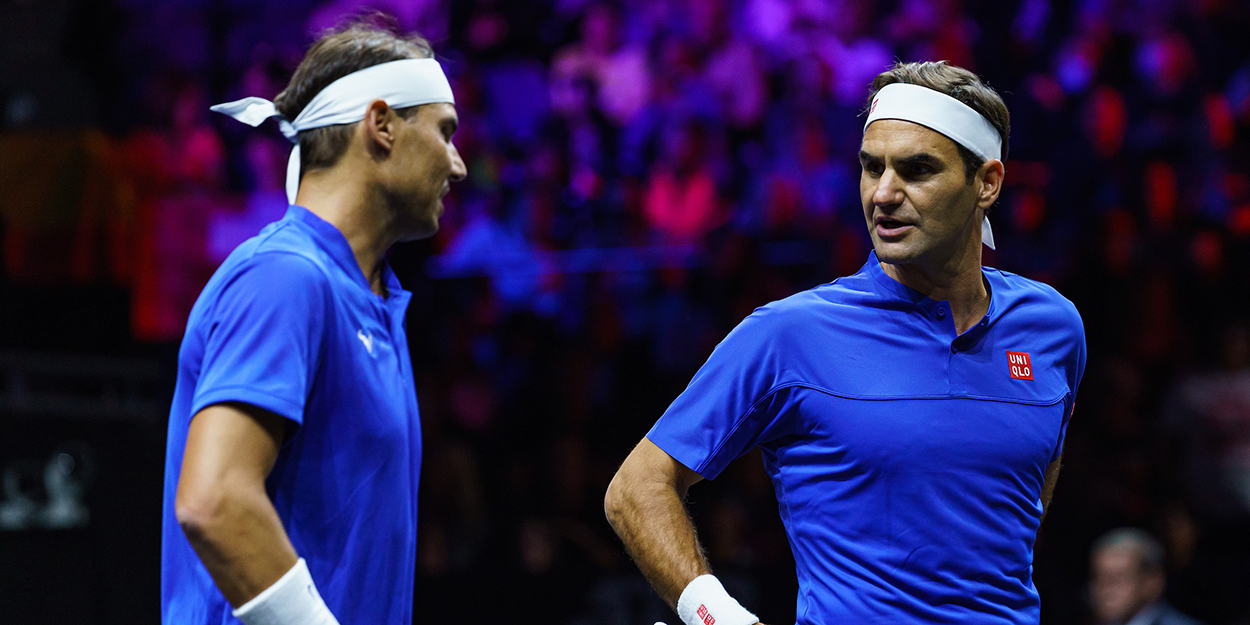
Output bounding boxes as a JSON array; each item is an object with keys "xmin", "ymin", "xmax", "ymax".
[{"xmin": 274, "ymin": 18, "xmax": 434, "ymax": 176}]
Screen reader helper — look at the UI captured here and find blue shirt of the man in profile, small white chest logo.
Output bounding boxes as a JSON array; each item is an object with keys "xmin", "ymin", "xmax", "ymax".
[{"xmin": 161, "ymin": 206, "xmax": 421, "ymax": 625}]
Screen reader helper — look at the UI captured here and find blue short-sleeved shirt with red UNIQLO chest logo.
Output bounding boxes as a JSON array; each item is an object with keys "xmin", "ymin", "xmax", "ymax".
[{"xmin": 648, "ymin": 254, "xmax": 1085, "ymax": 625}]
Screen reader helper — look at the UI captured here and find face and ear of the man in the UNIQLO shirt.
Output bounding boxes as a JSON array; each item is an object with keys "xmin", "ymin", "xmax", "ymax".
[{"xmin": 860, "ymin": 120, "xmax": 1001, "ymax": 268}]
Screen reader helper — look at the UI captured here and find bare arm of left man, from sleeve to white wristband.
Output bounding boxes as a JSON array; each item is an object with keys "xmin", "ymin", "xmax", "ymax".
[{"xmin": 175, "ymin": 404, "xmax": 299, "ymax": 608}]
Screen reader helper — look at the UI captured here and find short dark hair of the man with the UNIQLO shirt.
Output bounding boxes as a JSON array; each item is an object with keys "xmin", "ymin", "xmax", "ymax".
[{"xmin": 868, "ymin": 61, "xmax": 1011, "ymax": 184}]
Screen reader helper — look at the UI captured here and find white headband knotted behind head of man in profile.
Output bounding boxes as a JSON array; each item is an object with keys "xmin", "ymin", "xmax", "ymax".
[{"xmin": 210, "ymin": 59, "xmax": 456, "ymax": 204}]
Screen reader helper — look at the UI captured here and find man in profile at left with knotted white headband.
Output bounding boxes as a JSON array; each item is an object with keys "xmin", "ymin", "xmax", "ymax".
[{"xmin": 161, "ymin": 24, "xmax": 465, "ymax": 625}]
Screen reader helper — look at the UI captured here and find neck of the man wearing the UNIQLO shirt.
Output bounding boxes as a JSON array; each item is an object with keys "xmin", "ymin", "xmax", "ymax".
[{"xmin": 881, "ymin": 241, "xmax": 990, "ymax": 334}]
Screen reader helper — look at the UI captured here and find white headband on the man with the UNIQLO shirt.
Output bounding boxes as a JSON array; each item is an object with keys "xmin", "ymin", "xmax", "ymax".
[{"xmin": 864, "ymin": 83, "xmax": 1003, "ymax": 250}]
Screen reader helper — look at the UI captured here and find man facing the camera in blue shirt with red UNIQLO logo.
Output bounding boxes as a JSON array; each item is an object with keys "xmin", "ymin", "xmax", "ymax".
[{"xmin": 605, "ymin": 63, "xmax": 1085, "ymax": 625}]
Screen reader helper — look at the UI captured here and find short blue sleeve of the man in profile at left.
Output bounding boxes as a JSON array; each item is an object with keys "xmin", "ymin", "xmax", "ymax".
[{"xmin": 191, "ymin": 253, "xmax": 330, "ymax": 424}]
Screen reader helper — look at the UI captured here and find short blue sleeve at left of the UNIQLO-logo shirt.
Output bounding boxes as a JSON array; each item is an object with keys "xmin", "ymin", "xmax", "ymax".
[{"xmin": 646, "ymin": 308, "xmax": 788, "ymax": 479}]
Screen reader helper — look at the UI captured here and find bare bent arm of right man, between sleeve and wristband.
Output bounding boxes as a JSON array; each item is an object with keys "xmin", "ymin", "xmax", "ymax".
[{"xmin": 604, "ymin": 438, "xmax": 709, "ymax": 610}]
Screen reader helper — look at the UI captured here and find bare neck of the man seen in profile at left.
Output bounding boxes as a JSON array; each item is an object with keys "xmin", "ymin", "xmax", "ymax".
[{"xmin": 295, "ymin": 164, "xmax": 396, "ymax": 296}]
